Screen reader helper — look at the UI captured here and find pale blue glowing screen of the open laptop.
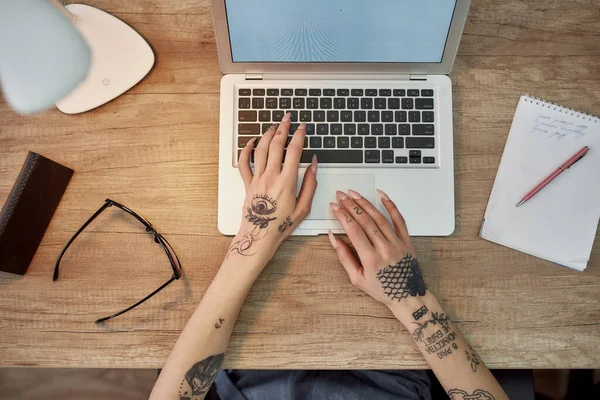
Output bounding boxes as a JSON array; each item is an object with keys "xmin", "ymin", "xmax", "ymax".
[{"xmin": 225, "ymin": 0, "xmax": 456, "ymax": 63}]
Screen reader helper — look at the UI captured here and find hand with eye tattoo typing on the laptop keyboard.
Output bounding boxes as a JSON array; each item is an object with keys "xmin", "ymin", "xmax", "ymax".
[{"xmin": 227, "ymin": 113, "xmax": 317, "ymax": 264}]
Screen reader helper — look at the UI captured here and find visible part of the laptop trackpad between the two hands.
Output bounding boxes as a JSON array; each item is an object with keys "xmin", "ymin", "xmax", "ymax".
[{"xmin": 298, "ymin": 174, "xmax": 375, "ymax": 220}]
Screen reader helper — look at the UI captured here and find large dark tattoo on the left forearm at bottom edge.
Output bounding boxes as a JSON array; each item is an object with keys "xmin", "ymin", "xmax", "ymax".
[{"xmin": 179, "ymin": 353, "xmax": 225, "ymax": 400}]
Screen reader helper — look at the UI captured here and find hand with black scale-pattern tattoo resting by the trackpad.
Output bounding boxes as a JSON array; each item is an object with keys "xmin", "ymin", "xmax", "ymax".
[{"xmin": 329, "ymin": 190, "xmax": 427, "ymax": 306}]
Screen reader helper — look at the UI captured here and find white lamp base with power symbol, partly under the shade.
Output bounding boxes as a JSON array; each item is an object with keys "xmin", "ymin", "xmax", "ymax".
[{"xmin": 56, "ymin": 4, "xmax": 154, "ymax": 114}]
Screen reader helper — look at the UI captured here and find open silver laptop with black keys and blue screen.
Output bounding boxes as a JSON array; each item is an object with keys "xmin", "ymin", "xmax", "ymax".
[{"xmin": 212, "ymin": 0, "xmax": 470, "ymax": 236}]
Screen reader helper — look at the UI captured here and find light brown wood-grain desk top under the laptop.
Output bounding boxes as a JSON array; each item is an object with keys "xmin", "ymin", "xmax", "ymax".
[{"xmin": 0, "ymin": 0, "xmax": 600, "ymax": 369}]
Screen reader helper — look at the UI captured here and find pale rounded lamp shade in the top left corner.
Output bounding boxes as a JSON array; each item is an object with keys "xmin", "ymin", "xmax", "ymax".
[{"xmin": 0, "ymin": 0, "xmax": 91, "ymax": 114}]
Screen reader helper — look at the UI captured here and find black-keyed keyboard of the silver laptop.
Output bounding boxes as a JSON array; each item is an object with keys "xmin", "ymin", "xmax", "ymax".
[{"xmin": 236, "ymin": 87, "xmax": 438, "ymax": 167}]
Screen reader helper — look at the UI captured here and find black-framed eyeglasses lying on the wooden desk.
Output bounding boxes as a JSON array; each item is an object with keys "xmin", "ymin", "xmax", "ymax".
[{"xmin": 52, "ymin": 199, "xmax": 183, "ymax": 323}]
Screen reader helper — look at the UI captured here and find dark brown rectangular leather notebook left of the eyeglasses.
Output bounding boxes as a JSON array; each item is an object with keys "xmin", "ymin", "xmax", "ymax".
[{"xmin": 0, "ymin": 152, "xmax": 73, "ymax": 275}]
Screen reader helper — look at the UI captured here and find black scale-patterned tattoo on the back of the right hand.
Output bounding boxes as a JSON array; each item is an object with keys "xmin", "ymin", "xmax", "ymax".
[{"xmin": 377, "ymin": 253, "xmax": 427, "ymax": 301}]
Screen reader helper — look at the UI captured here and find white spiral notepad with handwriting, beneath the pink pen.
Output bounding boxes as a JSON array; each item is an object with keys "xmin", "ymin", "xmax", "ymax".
[{"xmin": 480, "ymin": 95, "xmax": 600, "ymax": 271}]
